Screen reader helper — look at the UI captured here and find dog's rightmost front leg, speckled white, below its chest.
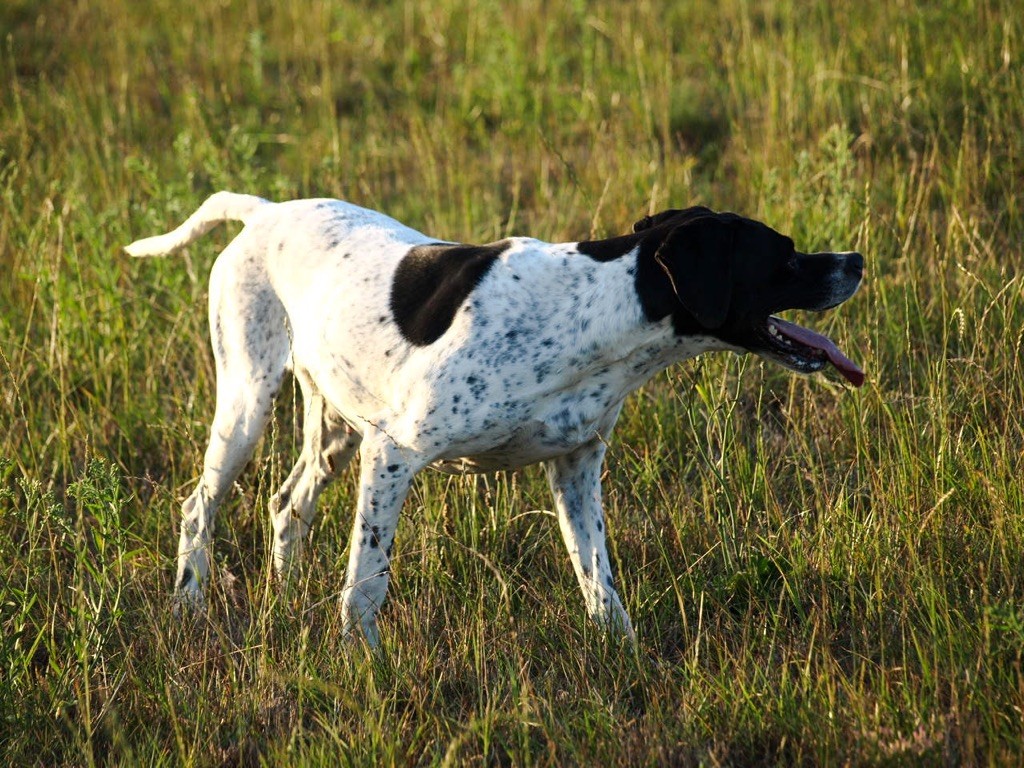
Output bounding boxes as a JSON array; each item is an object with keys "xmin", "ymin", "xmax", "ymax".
[{"xmin": 546, "ymin": 439, "xmax": 636, "ymax": 640}]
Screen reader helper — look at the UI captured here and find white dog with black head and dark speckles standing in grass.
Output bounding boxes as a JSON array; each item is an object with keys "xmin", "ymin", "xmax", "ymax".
[{"xmin": 126, "ymin": 191, "xmax": 864, "ymax": 645}]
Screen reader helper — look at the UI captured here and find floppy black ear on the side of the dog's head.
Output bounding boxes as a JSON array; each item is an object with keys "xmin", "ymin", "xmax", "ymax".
[{"xmin": 654, "ymin": 216, "xmax": 735, "ymax": 329}]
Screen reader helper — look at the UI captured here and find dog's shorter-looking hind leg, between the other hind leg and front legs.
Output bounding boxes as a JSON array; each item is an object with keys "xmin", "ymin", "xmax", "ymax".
[{"xmin": 270, "ymin": 370, "xmax": 362, "ymax": 577}]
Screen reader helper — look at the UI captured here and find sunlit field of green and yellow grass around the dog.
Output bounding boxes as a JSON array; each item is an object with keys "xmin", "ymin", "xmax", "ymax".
[{"xmin": 0, "ymin": 0, "xmax": 1024, "ymax": 766}]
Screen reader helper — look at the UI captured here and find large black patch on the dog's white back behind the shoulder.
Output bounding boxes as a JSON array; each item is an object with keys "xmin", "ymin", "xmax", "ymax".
[{"xmin": 391, "ymin": 240, "xmax": 509, "ymax": 346}]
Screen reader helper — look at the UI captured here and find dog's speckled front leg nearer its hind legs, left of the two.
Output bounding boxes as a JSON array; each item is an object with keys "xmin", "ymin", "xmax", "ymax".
[{"xmin": 341, "ymin": 432, "xmax": 422, "ymax": 647}]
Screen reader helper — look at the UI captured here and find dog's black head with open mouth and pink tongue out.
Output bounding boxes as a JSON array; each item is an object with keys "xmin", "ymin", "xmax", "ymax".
[{"xmin": 632, "ymin": 208, "xmax": 864, "ymax": 386}]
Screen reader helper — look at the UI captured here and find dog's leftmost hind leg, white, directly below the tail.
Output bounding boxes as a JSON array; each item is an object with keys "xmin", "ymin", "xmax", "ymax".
[{"xmin": 174, "ymin": 249, "xmax": 290, "ymax": 604}]
